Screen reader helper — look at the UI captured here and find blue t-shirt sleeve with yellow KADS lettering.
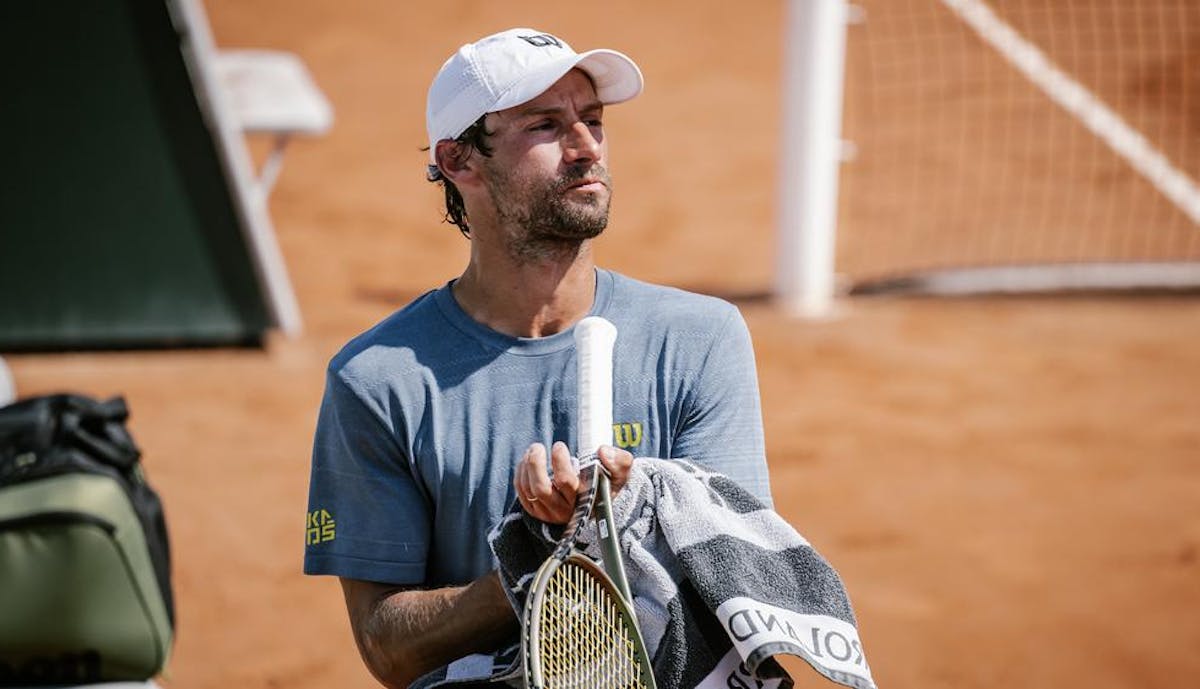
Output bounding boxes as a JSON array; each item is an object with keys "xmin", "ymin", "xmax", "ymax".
[{"xmin": 304, "ymin": 369, "xmax": 430, "ymax": 585}]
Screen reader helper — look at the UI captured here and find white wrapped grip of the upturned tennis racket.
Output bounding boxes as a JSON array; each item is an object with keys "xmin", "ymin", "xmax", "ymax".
[{"xmin": 575, "ymin": 316, "xmax": 617, "ymax": 457}]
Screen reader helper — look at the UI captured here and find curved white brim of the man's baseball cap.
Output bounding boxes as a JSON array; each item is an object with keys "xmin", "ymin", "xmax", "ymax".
[{"xmin": 488, "ymin": 48, "xmax": 643, "ymax": 113}]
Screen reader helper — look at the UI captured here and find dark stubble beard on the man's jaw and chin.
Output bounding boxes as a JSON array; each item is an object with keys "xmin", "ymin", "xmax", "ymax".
[{"xmin": 487, "ymin": 164, "xmax": 612, "ymax": 263}]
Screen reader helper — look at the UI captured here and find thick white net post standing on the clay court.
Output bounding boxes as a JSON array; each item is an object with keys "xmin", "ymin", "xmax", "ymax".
[{"xmin": 775, "ymin": 0, "xmax": 847, "ymax": 318}]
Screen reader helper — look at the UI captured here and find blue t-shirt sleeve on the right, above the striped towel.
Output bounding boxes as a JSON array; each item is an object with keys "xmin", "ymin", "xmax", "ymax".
[{"xmin": 672, "ymin": 306, "xmax": 773, "ymax": 507}]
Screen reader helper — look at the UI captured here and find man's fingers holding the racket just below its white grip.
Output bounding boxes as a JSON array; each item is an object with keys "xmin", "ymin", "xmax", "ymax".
[{"xmin": 512, "ymin": 442, "xmax": 634, "ymax": 523}]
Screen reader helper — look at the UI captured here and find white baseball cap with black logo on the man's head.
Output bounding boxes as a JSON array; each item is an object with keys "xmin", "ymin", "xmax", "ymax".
[{"xmin": 425, "ymin": 29, "xmax": 642, "ymax": 162}]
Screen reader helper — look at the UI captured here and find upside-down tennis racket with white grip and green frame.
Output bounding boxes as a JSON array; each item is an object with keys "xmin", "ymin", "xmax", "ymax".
[{"xmin": 521, "ymin": 317, "xmax": 655, "ymax": 689}]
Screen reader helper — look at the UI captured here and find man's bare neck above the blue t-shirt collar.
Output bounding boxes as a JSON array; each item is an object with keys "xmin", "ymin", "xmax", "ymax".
[{"xmin": 454, "ymin": 241, "xmax": 595, "ymax": 337}]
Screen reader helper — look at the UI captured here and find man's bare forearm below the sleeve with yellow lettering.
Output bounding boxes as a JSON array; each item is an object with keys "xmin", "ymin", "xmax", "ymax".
[{"xmin": 342, "ymin": 573, "xmax": 517, "ymax": 689}]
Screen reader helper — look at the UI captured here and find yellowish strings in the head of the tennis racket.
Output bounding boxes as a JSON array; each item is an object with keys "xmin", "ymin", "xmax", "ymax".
[{"xmin": 540, "ymin": 563, "xmax": 646, "ymax": 689}]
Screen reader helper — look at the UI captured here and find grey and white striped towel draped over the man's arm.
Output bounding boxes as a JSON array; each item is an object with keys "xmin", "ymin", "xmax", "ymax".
[{"xmin": 410, "ymin": 457, "xmax": 875, "ymax": 689}]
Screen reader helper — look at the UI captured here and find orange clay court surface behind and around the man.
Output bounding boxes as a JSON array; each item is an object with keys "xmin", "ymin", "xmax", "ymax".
[{"xmin": 6, "ymin": 0, "xmax": 1200, "ymax": 689}]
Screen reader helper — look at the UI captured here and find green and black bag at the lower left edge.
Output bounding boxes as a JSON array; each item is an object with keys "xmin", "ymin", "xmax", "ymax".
[{"xmin": 0, "ymin": 395, "xmax": 175, "ymax": 687}]
